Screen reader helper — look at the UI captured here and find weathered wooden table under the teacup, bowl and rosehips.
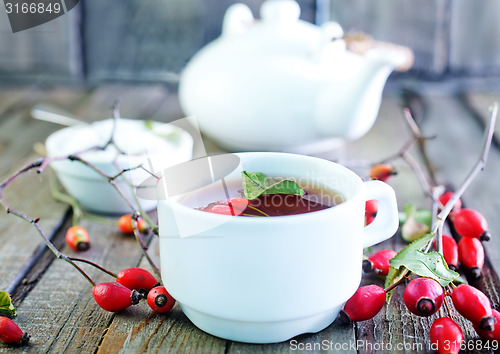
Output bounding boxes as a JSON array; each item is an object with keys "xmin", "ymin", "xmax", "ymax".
[{"xmin": 0, "ymin": 84, "xmax": 500, "ymax": 353}]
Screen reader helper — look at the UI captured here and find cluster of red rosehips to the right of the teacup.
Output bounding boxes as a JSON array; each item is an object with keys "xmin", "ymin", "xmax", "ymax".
[{"xmin": 360, "ymin": 164, "xmax": 500, "ymax": 353}]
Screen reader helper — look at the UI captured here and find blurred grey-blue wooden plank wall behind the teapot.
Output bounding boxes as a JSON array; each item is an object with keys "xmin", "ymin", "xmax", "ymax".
[{"xmin": 0, "ymin": 0, "xmax": 500, "ymax": 90}]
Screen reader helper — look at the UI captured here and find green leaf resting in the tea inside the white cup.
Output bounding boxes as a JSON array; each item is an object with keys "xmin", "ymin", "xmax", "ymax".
[{"xmin": 242, "ymin": 171, "xmax": 304, "ymax": 200}]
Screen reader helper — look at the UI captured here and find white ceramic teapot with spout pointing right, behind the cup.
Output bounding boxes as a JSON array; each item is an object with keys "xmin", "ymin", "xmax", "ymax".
[{"xmin": 179, "ymin": 0, "xmax": 407, "ymax": 151}]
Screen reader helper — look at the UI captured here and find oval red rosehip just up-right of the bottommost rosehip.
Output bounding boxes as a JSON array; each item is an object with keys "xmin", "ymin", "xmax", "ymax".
[{"xmin": 451, "ymin": 284, "xmax": 495, "ymax": 332}]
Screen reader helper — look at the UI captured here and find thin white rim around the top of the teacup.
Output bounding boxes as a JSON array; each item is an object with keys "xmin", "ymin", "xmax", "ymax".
[{"xmin": 158, "ymin": 152, "xmax": 363, "ymax": 223}]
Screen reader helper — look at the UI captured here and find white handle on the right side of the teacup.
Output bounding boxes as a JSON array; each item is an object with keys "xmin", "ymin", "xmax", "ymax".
[{"xmin": 363, "ymin": 181, "xmax": 399, "ymax": 248}]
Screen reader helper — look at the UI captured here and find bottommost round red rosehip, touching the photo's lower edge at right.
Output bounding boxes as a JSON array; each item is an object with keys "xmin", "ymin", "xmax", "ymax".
[{"xmin": 430, "ymin": 317, "xmax": 464, "ymax": 354}]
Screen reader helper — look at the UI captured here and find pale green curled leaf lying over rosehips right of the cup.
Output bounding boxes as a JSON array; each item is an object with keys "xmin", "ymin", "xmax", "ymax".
[{"xmin": 390, "ymin": 249, "xmax": 459, "ymax": 287}]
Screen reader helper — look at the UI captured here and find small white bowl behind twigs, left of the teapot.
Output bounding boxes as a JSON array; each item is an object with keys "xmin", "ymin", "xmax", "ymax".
[{"xmin": 45, "ymin": 119, "xmax": 193, "ymax": 214}]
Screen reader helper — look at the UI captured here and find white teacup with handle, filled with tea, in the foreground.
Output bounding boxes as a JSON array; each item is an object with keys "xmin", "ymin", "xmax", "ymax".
[{"xmin": 158, "ymin": 153, "xmax": 398, "ymax": 343}]
